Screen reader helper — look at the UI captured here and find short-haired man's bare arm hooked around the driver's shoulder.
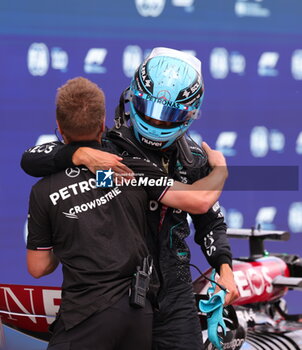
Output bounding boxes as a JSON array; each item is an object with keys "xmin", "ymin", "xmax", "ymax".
[{"xmin": 160, "ymin": 142, "xmax": 228, "ymax": 214}]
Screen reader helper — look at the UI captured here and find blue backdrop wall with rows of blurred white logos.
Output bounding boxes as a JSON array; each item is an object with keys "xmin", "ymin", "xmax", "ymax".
[{"xmin": 0, "ymin": 0, "xmax": 302, "ymax": 312}]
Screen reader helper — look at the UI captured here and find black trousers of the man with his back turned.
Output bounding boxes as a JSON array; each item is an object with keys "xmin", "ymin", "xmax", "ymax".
[{"xmin": 47, "ymin": 296, "xmax": 153, "ymax": 350}]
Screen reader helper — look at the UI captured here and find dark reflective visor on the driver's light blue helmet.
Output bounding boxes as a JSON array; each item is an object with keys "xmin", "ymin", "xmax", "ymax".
[{"xmin": 132, "ymin": 90, "xmax": 199, "ymax": 123}]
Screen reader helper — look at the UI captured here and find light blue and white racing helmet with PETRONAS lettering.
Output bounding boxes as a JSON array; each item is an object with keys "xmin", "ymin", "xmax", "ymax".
[{"xmin": 129, "ymin": 47, "xmax": 204, "ymax": 150}]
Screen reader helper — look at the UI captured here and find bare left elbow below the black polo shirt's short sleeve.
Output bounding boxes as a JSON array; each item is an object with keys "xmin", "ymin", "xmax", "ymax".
[{"xmin": 27, "ymin": 249, "xmax": 59, "ymax": 278}]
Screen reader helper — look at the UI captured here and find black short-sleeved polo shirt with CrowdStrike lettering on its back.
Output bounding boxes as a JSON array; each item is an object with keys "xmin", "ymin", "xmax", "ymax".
[{"xmin": 27, "ymin": 145, "xmax": 167, "ymax": 329}]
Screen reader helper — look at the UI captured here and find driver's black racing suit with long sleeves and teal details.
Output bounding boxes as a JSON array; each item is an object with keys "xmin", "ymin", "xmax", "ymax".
[{"xmin": 21, "ymin": 126, "xmax": 232, "ymax": 350}]
